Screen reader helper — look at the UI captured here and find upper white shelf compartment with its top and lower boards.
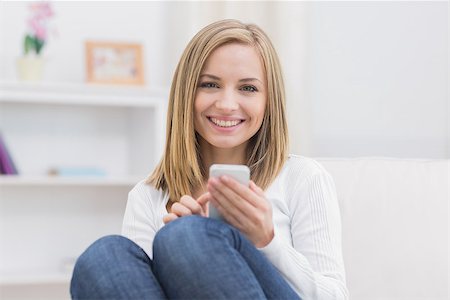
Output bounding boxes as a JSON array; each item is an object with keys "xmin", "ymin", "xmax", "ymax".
[{"xmin": 0, "ymin": 81, "xmax": 167, "ymax": 178}]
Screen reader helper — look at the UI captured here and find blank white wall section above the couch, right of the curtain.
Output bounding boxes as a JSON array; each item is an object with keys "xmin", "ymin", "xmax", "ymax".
[{"xmin": 307, "ymin": 2, "xmax": 449, "ymax": 157}]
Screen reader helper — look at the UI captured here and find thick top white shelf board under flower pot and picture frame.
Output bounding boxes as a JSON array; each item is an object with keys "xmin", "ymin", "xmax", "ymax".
[{"xmin": 0, "ymin": 81, "xmax": 167, "ymax": 108}]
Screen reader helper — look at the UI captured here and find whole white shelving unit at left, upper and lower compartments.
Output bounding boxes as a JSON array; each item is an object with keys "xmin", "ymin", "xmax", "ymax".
[{"xmin": 0, "ymin": 81, "xmax": 167, "ymax": 288}]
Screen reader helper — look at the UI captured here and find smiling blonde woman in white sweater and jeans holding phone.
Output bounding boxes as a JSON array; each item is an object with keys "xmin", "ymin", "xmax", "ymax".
[{"xmin": 71, "ymin": 20, "xmax": 348, "ymax": 300}]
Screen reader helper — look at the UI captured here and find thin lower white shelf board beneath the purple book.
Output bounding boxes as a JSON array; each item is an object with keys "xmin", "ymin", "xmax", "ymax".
[{"xmin": 0, "ymin": 175, "xmax": 143, "ymax": 187}]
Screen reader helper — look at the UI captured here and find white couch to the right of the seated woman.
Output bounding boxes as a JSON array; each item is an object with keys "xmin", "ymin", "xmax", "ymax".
[{"xmin": 317, "ymin": 158, "xmax": 449, "ymax": 300}]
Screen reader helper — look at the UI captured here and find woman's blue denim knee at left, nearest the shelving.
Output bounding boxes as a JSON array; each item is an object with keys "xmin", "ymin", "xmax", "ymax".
[{"xmin": 70, "ymin": 235, "xmax": 165, "ymax": 299}]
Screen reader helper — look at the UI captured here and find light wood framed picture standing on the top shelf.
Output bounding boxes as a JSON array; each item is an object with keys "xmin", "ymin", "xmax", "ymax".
[{"xmin": 85, "ymin": 41, "xmax": 144, "ymax": 85}]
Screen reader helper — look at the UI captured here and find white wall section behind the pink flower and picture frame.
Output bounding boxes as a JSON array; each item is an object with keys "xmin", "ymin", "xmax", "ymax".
[{"xmin": 0, "ymin": 2, "xmax": 169, "ymax": 85}]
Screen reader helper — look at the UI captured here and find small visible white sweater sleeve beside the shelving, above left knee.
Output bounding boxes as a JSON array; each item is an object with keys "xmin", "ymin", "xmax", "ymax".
[{"xmin": 122, "ymin": 182, "xmax": 158, "ymax": 258}]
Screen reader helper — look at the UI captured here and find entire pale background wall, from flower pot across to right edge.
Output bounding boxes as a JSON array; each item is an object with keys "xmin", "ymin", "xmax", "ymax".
[{"xmin": 0, "ymin": 2, "xmax": 449, "ymax": 158}]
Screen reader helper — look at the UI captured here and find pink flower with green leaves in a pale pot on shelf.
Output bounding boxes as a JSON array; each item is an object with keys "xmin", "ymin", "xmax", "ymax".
[{"xmin": 16, "ymin": 2, "xmax": 54, "ymax": 80}]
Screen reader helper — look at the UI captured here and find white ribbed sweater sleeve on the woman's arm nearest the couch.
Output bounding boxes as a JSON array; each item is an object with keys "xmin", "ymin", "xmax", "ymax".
[{"xmin": 260, "ymin": 168, "xmax": 348, "ymax": 300}]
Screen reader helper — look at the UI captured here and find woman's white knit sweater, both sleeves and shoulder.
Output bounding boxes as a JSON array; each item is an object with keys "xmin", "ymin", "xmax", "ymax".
[{"xmin": 122, "ymin": 155, "xmax": 348, "ymax": 300}]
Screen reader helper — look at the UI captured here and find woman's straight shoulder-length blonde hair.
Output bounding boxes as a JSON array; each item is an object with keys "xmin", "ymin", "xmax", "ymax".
[{"xmin": 147, "ymin": 20, "xmax": 288, "ymax": 202}]
